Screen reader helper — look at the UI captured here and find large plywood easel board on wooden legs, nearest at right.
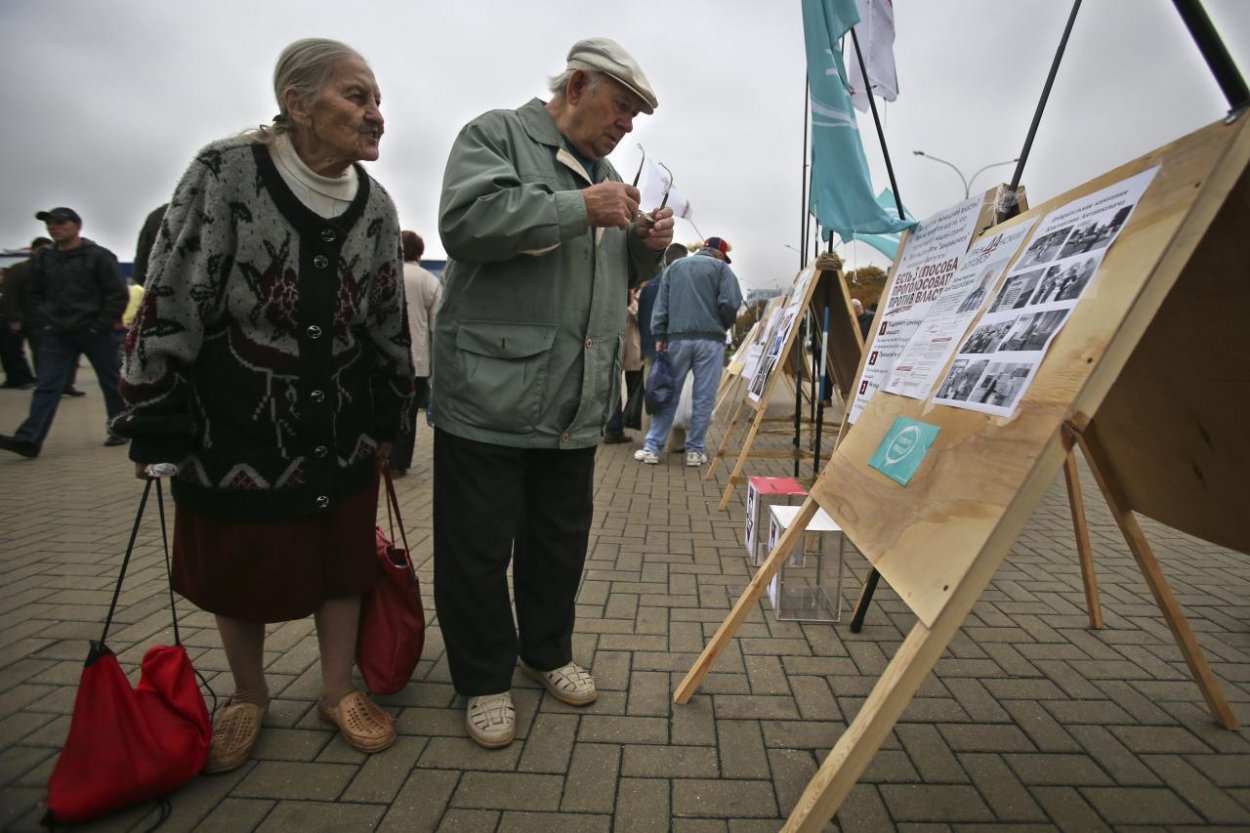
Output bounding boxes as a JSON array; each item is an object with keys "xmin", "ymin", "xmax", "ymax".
[{"xmin": 674, "ymin": 118, "xmax": 1250, "ymax": 832}]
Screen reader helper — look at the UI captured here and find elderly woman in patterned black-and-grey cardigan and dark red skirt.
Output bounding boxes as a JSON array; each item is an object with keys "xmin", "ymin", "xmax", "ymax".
[{"xmin": 115, "ymin": 39, "xmax": 413, "ymax": 772}]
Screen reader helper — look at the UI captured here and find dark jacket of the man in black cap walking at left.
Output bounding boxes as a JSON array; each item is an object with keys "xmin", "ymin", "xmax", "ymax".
[{"xmin": 26, "ymin": 239, "xmax": 130, "ymax": 334}]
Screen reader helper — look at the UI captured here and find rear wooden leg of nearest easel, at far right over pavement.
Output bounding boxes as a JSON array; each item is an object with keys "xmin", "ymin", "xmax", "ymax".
[{"xmin": 1074, "ymin": 417, "xmax": 1238, "ymax": 732}]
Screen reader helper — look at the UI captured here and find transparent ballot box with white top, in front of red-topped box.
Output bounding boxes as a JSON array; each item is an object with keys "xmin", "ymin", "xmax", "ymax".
[{"xmin": 765, "ymin": 505, "xmax": 846, "ymax": 622}]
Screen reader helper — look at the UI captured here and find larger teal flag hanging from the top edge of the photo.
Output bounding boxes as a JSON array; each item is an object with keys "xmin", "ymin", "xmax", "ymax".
[{"xmin": 803, "ymin": 0, "xmax": 915, "ymax": 240}]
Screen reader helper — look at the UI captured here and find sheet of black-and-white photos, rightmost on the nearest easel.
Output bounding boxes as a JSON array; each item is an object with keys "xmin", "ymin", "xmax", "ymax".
[{"xmin": 935, "ymin": 166, "xmax": 1159, "ymax": 417}]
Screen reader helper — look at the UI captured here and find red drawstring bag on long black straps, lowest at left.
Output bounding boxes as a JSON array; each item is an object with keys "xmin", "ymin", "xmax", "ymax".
[{"xmin": 45, "ymin": 478, "xmax": 213, "ymax": 825}]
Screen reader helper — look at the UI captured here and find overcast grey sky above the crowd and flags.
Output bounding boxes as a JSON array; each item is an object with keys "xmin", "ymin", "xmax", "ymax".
[{"xmin": 0, "ymin": 0, "xmax": 1250, "ymax": 288}]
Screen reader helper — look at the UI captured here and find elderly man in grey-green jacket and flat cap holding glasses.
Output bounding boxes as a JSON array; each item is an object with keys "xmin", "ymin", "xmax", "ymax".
[{"xmin": 433, "ymin": 38, "xmax": 673, "ymax": 748}]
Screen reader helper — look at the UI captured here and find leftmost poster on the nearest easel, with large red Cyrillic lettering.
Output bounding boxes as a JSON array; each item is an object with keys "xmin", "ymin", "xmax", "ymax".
[{"xmin": 848, "ymin": 196, "xmax": 981, "ymax": 423}]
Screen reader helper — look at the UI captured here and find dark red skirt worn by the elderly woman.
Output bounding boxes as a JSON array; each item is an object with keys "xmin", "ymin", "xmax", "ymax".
[{"xmin": 171, "ymin": 480, "xmax": 379, "ymax": 623}]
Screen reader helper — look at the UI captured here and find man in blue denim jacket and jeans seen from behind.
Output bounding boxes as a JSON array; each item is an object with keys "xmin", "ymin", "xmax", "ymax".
[{"xmin": 634, "ymin": 238, "xmax": 743, "ymax": 467}]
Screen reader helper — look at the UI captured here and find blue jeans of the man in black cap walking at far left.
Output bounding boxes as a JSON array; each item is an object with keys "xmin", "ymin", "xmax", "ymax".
[{"xmin": 15, "ymin": 330, "xmax": 123, "ymax": 449}]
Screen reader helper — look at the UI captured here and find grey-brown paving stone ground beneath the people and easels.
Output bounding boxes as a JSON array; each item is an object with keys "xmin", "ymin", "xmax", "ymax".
[{"xmin": 0, "ymin": 377, "xmax": 1250, "ymax": 833}]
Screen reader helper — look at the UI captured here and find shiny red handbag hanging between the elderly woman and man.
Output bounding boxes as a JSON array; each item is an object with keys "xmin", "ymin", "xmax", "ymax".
[{"xmin": 356, "ymin": 467, "xmax": 425, "ymax": 694}]
